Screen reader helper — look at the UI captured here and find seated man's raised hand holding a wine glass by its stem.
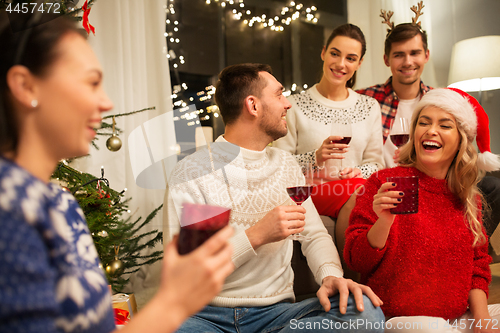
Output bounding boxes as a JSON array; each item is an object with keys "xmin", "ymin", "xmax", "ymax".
[{"xmin": 245, "ymin": 205, "xmax": 306, "ymax": 250}]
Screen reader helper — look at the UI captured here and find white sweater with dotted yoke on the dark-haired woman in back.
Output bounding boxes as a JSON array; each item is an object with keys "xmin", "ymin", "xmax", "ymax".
[{"xmin": 273, "ymin": 85, "xmax": 385, "ymax": 178}]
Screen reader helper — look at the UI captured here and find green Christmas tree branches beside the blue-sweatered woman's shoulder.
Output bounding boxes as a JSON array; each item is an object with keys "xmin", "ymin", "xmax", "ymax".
[{"xmin": 53, "ymin": 161, "xmax": 163, "ymax": 292}]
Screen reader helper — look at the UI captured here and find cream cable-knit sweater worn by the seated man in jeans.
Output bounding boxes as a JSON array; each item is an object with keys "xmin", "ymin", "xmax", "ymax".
[{"xmin": 163, "ymin": 136, "xmax": 343, "ymax": 307}]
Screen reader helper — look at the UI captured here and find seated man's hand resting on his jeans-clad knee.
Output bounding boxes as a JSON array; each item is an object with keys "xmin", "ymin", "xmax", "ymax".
[{"xmin": 316, "ymin": 276, "xmax": 383, "ymax": 314}]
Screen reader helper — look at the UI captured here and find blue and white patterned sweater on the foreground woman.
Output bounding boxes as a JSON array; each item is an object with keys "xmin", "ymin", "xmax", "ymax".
[{"xmin": 0, "ymin": 156, "xmax": 115, "ymax": 333}]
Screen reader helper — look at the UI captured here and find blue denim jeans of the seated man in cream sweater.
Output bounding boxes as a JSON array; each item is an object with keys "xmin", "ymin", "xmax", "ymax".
[{"xmin": 177, "ymin": 295, "xmax": 384, "ymax": 333}]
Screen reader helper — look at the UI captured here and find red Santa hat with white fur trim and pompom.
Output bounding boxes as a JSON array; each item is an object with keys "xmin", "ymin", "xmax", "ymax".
[{"xmin": 415, "ymin": 88, "xmax": 500, "ymax": 171}]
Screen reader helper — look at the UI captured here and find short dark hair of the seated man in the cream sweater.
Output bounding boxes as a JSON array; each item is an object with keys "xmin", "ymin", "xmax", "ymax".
[{"xmin": 215, "ymin": 64, "xmax": 272, "ymax": 125}]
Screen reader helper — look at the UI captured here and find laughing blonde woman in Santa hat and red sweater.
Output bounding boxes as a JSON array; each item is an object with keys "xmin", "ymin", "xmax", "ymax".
[{"xmin": 344, "ymin": 89, "xmax": 500, "ymax": 333}]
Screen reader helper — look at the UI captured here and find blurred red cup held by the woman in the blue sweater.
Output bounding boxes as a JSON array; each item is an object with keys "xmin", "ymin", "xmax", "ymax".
[{"xmin": 177, "ymin": 203, "xmax": 231, "ymax": 254}]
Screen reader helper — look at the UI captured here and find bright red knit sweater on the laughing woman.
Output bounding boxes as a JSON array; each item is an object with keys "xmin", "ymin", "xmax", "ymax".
[{"xmin": 344, "ymin": 167, "xmax": 491, "ymax": 319}]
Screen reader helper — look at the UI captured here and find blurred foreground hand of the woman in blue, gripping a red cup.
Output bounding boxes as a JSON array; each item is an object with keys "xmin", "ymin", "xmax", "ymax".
[{"xmin": 121, "ymin": 226, "xmax": 234, "ymax": 333}]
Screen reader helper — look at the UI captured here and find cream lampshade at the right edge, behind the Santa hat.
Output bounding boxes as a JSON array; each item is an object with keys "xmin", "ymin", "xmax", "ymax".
[{"xmin": 448, "ymin": 36, "xmax": 500, "ymax": 91}]
